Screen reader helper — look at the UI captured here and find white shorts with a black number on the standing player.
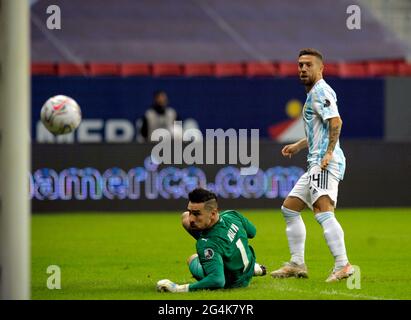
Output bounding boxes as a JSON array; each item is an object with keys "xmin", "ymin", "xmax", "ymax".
[{"xmin": 288, "ymin": 165, "xmax": 339, "ymax": 210}]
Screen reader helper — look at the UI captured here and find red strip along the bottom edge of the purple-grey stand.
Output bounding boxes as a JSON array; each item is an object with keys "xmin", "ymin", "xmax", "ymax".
[{"xmin": 31, "ymin": 60, "xmax": 411, "ymax": 78}]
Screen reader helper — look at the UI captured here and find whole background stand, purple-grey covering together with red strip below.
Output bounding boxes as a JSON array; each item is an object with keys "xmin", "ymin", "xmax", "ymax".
[{"xmin": 31, "ymin": 0, "xmax": 411, "ymax": 78}]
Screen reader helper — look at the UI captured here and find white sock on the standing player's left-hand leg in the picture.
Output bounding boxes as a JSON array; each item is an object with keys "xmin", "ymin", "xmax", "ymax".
[{"xmin": 281, "ymin": 206, "xmax": 306, "ymax": 264}]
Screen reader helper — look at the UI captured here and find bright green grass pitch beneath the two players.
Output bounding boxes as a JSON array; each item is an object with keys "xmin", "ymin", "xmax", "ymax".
[{"xmin": 31, "ymin": 208, "xmax": 411, "ymax": 300}]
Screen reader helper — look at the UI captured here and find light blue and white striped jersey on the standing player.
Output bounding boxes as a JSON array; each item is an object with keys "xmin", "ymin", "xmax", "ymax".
[{"xmin": 303, "ymin": 79, "xmax": 345, "ymax": 180}]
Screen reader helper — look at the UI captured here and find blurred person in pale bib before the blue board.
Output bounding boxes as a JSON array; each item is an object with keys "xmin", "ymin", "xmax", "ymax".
[{"xmin": 141, "ymin": 90, "xmax": 178, "ymax": 142}]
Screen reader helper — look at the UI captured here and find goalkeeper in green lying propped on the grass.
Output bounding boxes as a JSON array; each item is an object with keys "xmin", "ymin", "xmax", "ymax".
[{"xmin": 157, "ymin": 188, "xmax": 267, "ymax": 292}]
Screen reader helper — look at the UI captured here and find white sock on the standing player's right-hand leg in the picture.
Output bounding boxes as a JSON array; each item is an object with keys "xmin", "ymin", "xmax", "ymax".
[{"xmin": 315, "ymin": 211, "xmax": 348, "ymax": 269}]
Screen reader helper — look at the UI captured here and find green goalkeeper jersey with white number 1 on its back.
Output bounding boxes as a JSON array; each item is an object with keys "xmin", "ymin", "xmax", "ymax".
[{"xmin": 189, "ymin": 210, "xmax": 256, "ymax": 291}]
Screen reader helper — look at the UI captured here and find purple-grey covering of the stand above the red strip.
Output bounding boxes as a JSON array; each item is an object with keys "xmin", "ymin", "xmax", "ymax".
[{"xmin": 31, "ymin": 0, "xmax": 407, "ymax": 63}]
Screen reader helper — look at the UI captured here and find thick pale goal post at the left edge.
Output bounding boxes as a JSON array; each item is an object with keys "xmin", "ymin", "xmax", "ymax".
[{"xmin": 0, "ymin": 0, "xmax": 31, "ymax": 300}]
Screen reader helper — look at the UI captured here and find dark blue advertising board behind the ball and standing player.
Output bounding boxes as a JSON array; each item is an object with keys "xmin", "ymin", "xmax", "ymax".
[{"xmin": 32, "ymin": 76, "xmax": 385, "ymax": 143}]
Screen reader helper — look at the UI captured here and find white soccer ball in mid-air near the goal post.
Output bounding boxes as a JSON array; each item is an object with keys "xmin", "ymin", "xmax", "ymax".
[{"xmin": 40, "ymin": 95, "xmax": 81, "ymax": 135}]
